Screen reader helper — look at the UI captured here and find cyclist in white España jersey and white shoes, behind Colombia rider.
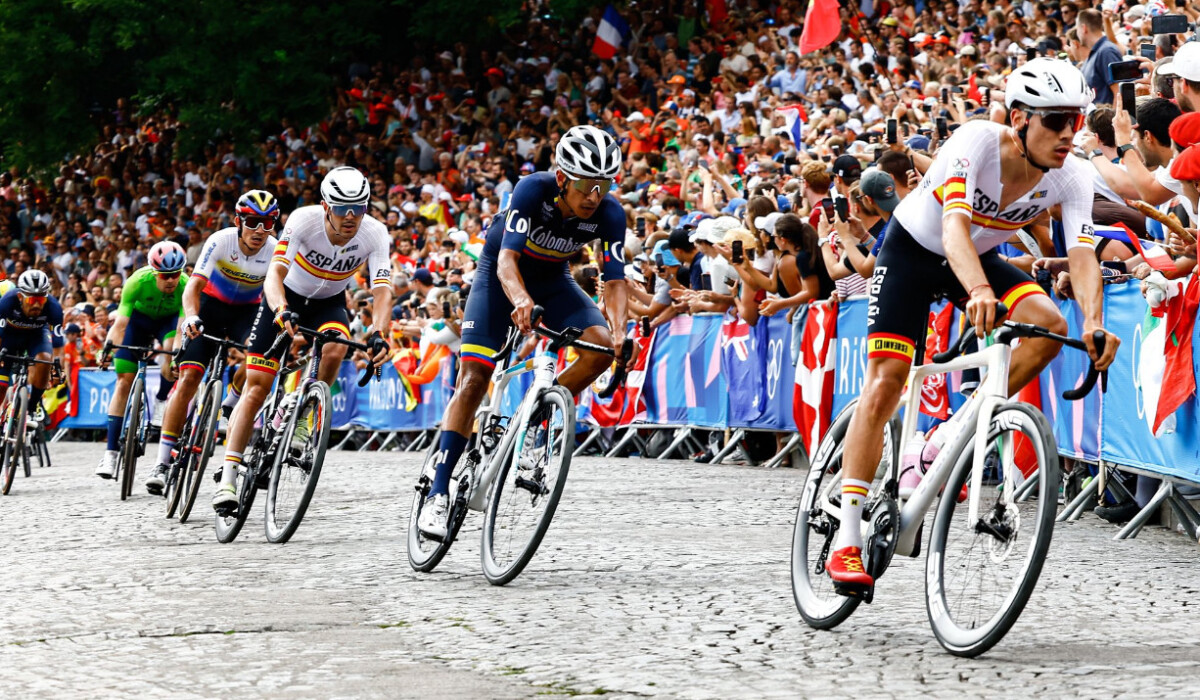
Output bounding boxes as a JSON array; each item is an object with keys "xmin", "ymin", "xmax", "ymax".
[{"xmin": 212, "ymin": 166, "xmax": 391, "ymax": 510}]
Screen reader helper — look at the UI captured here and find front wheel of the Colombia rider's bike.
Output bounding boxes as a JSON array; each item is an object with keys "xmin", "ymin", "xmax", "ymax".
[{"xmin": 481, "ymin": 387, "xmax": 575, "ymax": 586}]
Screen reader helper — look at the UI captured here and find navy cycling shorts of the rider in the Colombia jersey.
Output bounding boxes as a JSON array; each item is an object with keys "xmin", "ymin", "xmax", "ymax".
[{"xmin": 461, "ymin": 256, "xmax": 607, "ymax": 367}]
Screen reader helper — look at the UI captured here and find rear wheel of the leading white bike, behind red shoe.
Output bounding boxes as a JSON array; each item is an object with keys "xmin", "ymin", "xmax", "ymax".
[{"xmin": 792, "ymin": 400, "xmax": 900, "ymax": 629}]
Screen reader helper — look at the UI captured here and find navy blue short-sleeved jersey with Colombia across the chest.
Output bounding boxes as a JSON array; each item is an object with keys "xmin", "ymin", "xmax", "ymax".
[{"xmin": 481, "ymin": 173, "xmax": 625, "ymax": 281}]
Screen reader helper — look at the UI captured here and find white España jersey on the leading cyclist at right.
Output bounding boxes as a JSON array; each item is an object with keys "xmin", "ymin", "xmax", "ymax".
[{"xmin": 894, "ymin": 120, "xmax": 1094, "ymax": 256}]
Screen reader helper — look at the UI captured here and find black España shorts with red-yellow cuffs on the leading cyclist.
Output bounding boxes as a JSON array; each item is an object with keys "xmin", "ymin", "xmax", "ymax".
[{"xmin": 866, "ymin": 217, "xmax": 1045, "ymax": 363}]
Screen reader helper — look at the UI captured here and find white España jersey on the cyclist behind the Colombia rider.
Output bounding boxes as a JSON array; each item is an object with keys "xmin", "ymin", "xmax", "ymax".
[{"xmin": 271, "ymin": 204, "xmax": 391, "ymax": 299}]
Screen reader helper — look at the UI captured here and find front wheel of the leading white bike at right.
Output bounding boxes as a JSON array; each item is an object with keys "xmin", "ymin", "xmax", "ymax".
[{"xmin": 925, "ymin": 403, "xmax": 1058, "ymax": 657}]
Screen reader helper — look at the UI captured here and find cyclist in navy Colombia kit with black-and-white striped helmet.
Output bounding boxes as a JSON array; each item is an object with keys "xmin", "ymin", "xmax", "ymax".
[{"xmin": 418, "ymin": 126, "xmax": 628, "ymax": 537}]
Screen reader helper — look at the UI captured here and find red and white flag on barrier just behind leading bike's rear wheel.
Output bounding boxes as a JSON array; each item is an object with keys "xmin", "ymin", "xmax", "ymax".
[{"xmin": 792, "ymin": 303, "xmax": 838, "ymax": 455}]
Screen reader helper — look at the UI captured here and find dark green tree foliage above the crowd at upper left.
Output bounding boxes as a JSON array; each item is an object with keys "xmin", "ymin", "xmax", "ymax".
[{"xmin": 0, "ymin": 0, "xmax": 590, "ymax": 172}]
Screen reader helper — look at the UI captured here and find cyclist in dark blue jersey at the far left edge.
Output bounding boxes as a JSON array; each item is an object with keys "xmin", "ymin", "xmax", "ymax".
[{"xmin": 0, "ymin": 270, "xmax": 62, "ymax": 423}]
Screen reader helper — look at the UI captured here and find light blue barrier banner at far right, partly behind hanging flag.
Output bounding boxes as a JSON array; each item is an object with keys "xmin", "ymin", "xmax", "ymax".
[{"xmin": 1100, "ymin": 285, "xmax": 1200, "ymax": 481}]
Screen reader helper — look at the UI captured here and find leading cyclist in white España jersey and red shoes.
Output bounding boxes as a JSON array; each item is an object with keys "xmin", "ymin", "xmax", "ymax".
[{"xmin": 826, "ymin": 58, "xmax": 1121, "ymax": 596}]
